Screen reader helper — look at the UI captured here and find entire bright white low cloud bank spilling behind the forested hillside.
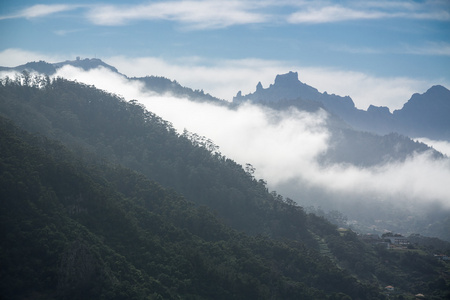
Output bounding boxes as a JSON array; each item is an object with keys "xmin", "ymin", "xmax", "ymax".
[{"xmin": 49, "ymin": 67, "xmax": 450, "ymax": 208}]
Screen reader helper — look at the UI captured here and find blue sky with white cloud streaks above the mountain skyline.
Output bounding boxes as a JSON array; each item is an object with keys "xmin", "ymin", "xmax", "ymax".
[{"xmin": 0, "ymin": 0, "xmax": 450, "ymax": 111}]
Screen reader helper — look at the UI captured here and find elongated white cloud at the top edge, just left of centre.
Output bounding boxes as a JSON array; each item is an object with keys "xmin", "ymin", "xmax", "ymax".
[{"xmin": 87, "ymin": 1, "xmax": 267, "ymax": 29}]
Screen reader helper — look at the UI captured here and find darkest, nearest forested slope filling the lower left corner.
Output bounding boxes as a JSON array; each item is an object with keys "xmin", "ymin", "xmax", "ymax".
[{"xmin": 0, "ymin": 118, "xmax": 379, "ymax": 299}]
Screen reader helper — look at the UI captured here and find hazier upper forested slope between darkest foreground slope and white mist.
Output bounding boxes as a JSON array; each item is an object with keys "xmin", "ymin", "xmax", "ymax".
[{"xmin": 0, "ymin": 79, "xmax": 315, "ymax": 246}]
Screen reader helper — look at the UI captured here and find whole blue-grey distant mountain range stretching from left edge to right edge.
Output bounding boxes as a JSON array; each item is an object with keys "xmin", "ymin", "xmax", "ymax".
[{"xmin": 0, "ymin": 57, "xmax": 450, "ymax": 141}]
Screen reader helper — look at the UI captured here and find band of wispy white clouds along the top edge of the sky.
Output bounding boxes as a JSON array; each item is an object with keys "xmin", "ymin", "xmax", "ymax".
[{"xmin": 0, "ymin": 0, "xmax": 450, "ymax": 26}]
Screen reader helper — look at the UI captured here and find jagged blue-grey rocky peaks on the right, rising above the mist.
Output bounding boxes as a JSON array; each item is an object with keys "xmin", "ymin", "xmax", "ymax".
[{"xmin": 233, "ymin": 72, "xmax": 450, "ymax": 141}]
